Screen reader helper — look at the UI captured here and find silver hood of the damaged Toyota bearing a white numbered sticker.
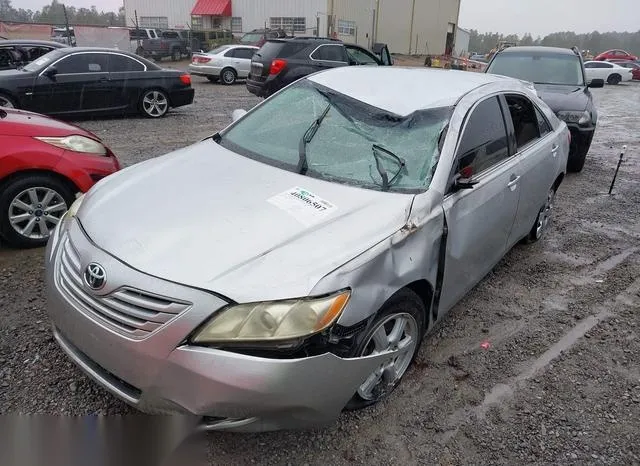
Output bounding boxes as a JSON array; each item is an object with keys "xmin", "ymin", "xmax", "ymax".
[{"xmin": 78, "ymin": 139, "xmax": 414, "ymax": 302}]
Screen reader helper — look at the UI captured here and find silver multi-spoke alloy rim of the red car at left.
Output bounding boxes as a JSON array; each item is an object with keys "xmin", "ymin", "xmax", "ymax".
[{"xmin": 8, "ymin": 187, "xmax": 67, "ymax": 240}]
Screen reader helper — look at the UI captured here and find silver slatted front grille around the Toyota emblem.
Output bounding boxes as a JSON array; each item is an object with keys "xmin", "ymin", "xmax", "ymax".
[{"xmin": 58, "ymin": 238, "xmax": 191, "ymax": 339}]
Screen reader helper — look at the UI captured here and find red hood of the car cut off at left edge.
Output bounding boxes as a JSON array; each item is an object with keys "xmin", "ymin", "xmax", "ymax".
[{"xmin": 0, "ymin": 108, "xmax": 99, "ymax": 140}]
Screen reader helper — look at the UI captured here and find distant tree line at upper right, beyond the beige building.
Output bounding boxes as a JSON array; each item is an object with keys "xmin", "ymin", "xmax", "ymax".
[{"xmin": 469, "ymin": 29, "xmax": 640, "ymax": 55}]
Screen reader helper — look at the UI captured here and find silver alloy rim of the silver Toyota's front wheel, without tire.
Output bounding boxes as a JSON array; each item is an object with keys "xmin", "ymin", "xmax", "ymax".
[{"xmin": 358, "ymin": 313, "xmax": 420, "ymax": 400}]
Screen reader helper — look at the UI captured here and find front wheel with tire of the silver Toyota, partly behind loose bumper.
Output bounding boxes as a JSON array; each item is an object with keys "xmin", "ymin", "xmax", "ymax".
[{"xmin": 345, "ymin": 289, "xmax": 427, "ymax": 411}]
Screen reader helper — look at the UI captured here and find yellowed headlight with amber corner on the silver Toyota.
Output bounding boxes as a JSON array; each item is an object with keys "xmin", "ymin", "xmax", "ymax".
[{"xmin": 192, "ymin": 291, "xmax": 351, "ymax": 343}]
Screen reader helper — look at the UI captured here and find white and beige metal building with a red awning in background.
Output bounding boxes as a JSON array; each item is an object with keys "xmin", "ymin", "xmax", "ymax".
[{"xmin": 124, "ymin": 0, "xmax": 461, "ymax": 55}]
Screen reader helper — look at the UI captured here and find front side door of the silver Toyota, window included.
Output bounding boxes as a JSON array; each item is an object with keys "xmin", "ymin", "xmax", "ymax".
[{"xmin": 440, "ymin": 97, "xmax": 520, "ymax": 312}]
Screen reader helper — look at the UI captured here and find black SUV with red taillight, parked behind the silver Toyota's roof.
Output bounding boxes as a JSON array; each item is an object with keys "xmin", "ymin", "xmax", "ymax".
[{"xmin": 247, "ymin": 37, "xmax": 393, "ymax": 97}]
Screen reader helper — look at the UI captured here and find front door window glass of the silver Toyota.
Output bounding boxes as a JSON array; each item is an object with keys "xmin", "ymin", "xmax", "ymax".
[{"xmin": 458, "ymin": 97, "xmax": 509, "ymax": 175}]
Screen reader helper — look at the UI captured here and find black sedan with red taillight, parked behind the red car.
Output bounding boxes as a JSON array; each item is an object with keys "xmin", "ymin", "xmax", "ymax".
[{"xmin": 0, "ymin": 47, "xmax": 194, "ymax": 118}]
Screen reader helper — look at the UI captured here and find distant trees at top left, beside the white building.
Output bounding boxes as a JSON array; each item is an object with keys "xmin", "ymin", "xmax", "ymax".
[{"xmin": 0, "ymin": 0, "xmax": 126, "ymax": 26}]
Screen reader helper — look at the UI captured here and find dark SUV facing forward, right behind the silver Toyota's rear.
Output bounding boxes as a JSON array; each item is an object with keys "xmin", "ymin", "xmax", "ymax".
[{"xmin": 485, "ymin": 46, "xmax": 604, "ymax": 172}]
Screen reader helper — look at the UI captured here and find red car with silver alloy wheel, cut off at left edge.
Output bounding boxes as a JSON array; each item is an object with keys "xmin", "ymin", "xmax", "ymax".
[{"xmin": 0, "ymin": 108, "xmax": 120, "ymax": 247}]
